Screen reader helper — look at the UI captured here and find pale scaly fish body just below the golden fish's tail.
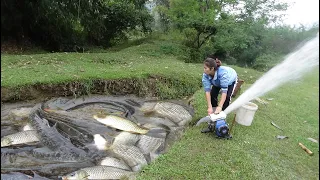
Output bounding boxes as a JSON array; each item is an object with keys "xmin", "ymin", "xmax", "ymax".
[{"xmin": 137, "ymin": 135, "xmax": 165, "ymax": 154}]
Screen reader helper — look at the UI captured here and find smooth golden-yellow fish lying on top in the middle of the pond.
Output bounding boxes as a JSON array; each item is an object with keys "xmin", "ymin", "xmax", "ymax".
[{"xmin": 93, "ymin": 115, "xmax": 149, "ymax": 134}]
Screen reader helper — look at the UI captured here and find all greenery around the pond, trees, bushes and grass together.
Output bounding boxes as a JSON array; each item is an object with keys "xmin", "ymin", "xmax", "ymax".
[{"xmin": 1, "ymin": 0, "xmax": 319, "ymax": 180}]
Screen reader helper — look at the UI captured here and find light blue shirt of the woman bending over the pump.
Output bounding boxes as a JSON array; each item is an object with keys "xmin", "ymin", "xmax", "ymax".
[{"xmin": 202, "ymin": 66, "xmax": 237, "ymax": 93}]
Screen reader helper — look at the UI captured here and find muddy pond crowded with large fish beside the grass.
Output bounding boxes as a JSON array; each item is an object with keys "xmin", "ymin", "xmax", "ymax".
[{"xmin": 1, "ymin": 95, "xmax": 193, "ymax": 179}]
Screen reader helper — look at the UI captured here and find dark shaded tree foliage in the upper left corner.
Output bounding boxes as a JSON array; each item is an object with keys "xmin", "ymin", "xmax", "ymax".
[{"xmin": 1, "ymin": 0, "xmax": 152, "ymax": 51}]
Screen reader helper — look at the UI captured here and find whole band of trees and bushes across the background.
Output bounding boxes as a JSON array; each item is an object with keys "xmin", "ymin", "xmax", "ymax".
[{"xmin": 1, "ymin": 0, "xmax": 319, "ymax": 71}]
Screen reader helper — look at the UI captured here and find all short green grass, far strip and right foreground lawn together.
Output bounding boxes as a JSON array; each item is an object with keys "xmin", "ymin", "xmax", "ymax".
[{"xmin": 1, "ymin": 42, "xmax": 319, "ymax": 180}]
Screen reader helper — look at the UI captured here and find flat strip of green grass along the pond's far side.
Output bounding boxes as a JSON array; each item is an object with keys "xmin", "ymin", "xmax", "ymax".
[{"xmin": 1, "ymin": 43, "xmax": 260, "ymax": 87}]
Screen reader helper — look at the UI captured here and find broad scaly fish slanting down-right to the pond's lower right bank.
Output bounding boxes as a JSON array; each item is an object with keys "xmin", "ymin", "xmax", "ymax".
[{"xmin": 111, "ymin": 144, "xmax": 148, "ymax": 171}]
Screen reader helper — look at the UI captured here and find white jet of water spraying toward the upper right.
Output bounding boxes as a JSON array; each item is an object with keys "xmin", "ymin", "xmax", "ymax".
[{"xmin": 224, "ymin": 32, "xmax": 319, "ymax": 114}]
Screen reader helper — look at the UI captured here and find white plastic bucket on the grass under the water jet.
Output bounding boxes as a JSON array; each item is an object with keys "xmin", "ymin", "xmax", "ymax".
[{"xmin": 236, "ymin": 102, "xmax": 258, "ymax": 126}]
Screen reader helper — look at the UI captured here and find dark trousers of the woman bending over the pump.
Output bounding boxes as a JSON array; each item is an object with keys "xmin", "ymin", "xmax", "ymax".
[{"xmin": 210, "ymin": 81, "xmax": 236, "ymax": 111}]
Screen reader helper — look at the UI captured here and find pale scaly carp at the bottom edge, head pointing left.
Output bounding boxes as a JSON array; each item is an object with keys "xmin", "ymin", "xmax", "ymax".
[{"xmin": 62, "ymin": 166, "xmax": 134, "ymax": 180}]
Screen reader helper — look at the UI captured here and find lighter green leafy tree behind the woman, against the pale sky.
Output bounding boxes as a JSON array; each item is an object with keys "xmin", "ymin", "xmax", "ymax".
[{"xmin": 154, "ymin": 0, "xmax": 318, "ymax": 66}]
